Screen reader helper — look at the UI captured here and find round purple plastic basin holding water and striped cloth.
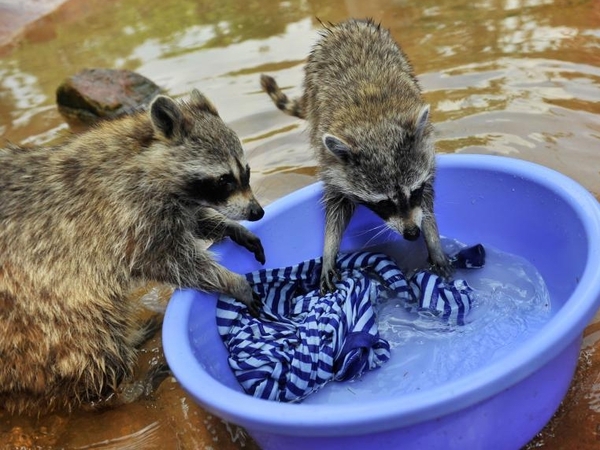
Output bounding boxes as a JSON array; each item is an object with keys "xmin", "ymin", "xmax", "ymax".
[{"xmin": 163, "ymin": 155, "xmax": 600, "ymax": 450}]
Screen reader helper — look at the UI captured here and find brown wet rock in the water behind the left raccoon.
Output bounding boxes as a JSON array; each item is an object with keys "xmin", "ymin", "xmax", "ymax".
[{"xmin": 56, "ymin": 69, "xmax": 161, "ymax": 125}]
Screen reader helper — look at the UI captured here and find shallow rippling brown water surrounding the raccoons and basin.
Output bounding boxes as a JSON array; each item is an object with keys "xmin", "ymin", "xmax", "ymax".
[{"xmin": 0, "ymin": 0, "xmax": 600, "ymax": 450}]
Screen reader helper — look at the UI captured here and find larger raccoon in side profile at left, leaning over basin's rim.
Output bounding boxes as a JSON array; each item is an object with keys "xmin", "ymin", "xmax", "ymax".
[{"xmin": 0, "ymin": 91, "xmax": 265, "ymax": 414}]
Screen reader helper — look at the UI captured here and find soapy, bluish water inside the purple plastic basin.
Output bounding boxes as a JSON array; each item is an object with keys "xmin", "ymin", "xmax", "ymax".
[{"xmin": 304, "ymin": 240, "xmax": 552, "ymax": 404}]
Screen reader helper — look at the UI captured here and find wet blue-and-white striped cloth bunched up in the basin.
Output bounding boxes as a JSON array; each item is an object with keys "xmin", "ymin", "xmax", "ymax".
[{"xmin": 217, "ymin": 252, "xmax": 480, "ymax": 402}]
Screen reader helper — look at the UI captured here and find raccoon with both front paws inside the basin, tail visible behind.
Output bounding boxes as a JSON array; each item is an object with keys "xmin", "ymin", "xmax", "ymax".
[{"xmin": 261, "ymin": 19, "xmax": 451, "ymax": 292}]
